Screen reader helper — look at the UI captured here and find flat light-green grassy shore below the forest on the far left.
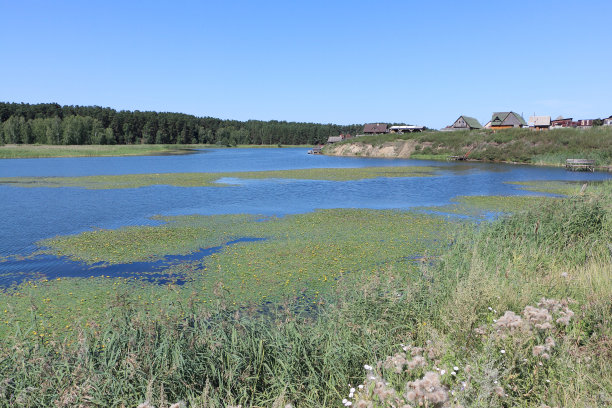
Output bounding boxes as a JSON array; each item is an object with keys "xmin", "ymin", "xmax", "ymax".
[{"xmin": 0, "ymin": 145, "xmax": 206, "ymax": 159}]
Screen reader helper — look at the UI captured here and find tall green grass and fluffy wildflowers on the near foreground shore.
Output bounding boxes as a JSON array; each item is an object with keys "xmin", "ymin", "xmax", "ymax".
[{"xmin": 0, "ymin": 182, "xmax": 612, "ymax": 407}]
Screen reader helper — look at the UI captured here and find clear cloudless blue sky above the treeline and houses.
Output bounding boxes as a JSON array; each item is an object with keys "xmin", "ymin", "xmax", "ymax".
[{"xmin": 0, "ymin": 0, "xmax": 612, "ymax": 128}]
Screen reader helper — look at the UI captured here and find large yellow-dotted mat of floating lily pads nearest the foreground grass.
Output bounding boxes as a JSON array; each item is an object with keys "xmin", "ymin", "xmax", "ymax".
[{"xmin": 0, "ymin": 209, "xmax": 457, "ymax": 337}]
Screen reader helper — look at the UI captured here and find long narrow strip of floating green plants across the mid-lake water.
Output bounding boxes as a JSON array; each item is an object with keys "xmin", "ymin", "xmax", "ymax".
[{"xmin": 0, "ymin": 166, "xmax": 437, "ymax": 189}]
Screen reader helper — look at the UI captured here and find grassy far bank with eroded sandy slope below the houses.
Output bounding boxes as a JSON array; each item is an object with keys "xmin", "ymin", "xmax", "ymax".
[{"xmin": 323, "ymin": 126, "xmax": 612, "ymax": 170}]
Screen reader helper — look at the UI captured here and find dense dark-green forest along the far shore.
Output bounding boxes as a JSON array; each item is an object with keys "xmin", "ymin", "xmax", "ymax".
[{"xmin": 0, "ymin": 102, "xmax": 363, "ymax": 146}]
